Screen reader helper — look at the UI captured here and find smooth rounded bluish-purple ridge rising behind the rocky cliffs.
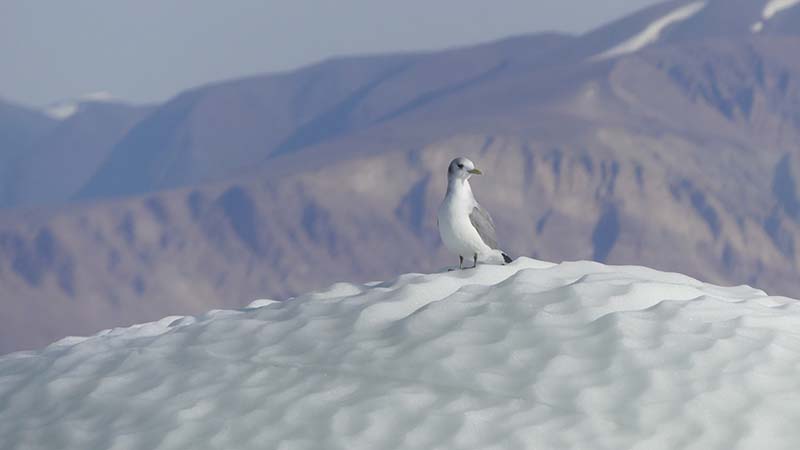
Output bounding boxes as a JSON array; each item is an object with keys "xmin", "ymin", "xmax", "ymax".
[{"xmin": 79, "ymin": 34, "xmax": 570, "ymax": 199}]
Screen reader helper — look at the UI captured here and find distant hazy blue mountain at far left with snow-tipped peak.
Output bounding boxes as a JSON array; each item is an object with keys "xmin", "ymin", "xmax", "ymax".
[{"xmin": 0, "ymin": 97, "xmax": 151, "ymax": 208}]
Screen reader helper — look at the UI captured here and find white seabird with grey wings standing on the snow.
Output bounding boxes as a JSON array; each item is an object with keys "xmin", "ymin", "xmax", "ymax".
[{"xmin": 437, "ymin": 158, "xmax": 512, "ymax": 269}]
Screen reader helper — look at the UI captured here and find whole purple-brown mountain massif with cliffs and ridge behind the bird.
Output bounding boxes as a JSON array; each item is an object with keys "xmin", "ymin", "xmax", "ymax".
[{"xmin": 0, "ymin": 1, "xmax": 800, "ymax": 351}]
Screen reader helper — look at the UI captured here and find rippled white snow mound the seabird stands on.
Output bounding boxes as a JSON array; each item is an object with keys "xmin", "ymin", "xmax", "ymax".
[{"xmin": 0, "ymin": 258, "xmax": 800, "ymax": 450}]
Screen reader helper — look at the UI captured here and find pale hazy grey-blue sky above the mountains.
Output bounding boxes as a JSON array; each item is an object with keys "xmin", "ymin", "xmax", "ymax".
[{"xmin": 0, "ymin": 0, "xmax": 658, "ymax": 106}]
